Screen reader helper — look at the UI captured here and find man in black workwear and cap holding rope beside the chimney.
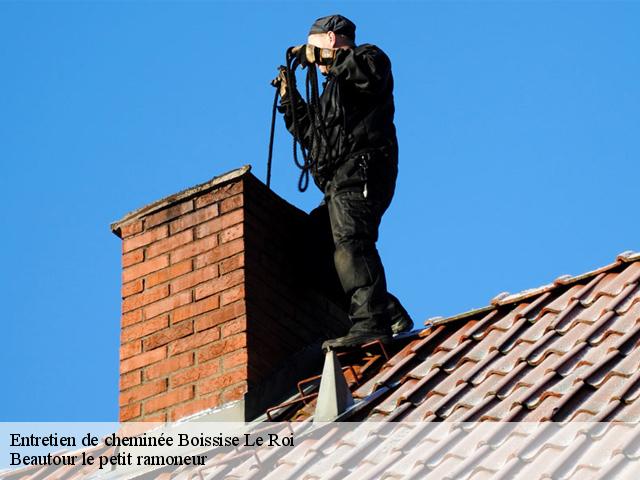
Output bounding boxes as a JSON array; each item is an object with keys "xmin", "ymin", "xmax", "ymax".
[{"xmin": 276, "ymin": 15, "xmax": 413, "ymax": 351}]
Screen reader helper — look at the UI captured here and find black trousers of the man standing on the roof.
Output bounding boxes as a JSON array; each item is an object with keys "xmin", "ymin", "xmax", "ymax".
[{"xmin": 310, "ymin": 152, "xmax": 406, "ymax": 333}]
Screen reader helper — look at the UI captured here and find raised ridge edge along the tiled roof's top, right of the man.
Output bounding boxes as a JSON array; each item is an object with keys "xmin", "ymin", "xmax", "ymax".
[{"xmin": 424, "ymin": 250, "xmax": 640, "ymax": 327}]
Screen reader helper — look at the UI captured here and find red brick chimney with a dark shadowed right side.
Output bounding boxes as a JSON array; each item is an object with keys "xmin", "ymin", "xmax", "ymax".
[{"xmin": 111, "ymin": 166, "xmax": 347, "ymax": 421}]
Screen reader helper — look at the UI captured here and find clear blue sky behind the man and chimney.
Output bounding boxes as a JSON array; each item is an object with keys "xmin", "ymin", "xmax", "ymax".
[{"xmin": 0, "ymin": 1, "xmax": 640, "ymax": 421}]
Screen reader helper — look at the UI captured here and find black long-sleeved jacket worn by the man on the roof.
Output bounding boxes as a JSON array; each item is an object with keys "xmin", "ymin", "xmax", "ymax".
[{"xmin": 279, "ymin": 44, "xmax": 398, "ymax": 191}]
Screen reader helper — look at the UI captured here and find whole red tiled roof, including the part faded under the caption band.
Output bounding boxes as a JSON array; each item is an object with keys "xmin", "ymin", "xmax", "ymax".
[{"xmin": 5, "ymin": 253, "xmax": 640, "ymax": 480}]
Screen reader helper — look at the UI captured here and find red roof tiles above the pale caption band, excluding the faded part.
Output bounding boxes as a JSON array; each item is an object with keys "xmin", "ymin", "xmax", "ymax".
[{"xmin": 354, "ymin": 249, "xmax": 640, "ymax": 421}]
